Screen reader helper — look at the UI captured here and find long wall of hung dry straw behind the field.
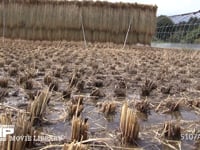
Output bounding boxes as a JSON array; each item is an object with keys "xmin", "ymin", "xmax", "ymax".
[{"xmin": 0, "ymin": 0, "xmax": 157, "ymax": 44}]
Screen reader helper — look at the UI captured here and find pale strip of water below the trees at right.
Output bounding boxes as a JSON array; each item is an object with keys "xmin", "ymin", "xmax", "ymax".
[{"xmin": 151, "ymin": 43, "xmax": 200, "ymax": 50}]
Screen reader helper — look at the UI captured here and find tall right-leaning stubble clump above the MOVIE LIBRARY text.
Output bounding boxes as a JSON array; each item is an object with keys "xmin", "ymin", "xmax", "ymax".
[{"xmin": 30, "ymin": 89, "xmax": 50, "ymax": 125}]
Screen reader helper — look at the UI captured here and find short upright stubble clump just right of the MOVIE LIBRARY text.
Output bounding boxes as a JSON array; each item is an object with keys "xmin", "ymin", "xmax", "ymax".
[{"xmin": 71, "ymin": 116, "xmax": 89, "ymax": 141}]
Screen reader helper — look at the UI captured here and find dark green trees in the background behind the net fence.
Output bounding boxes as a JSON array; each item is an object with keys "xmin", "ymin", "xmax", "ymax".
[{"xmin": 155, "ymin": 16, "xmax": 200, "ymax": 43}]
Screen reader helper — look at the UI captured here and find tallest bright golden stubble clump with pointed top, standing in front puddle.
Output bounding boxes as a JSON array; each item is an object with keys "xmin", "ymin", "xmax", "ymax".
[{"xmin": 120, "ymin": 103, "xmax": 139, "ymax": 143}]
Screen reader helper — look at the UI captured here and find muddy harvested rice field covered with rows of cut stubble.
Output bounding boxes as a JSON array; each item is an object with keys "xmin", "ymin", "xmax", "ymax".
[{"xmin": 0, "ymin": 39, "xmax": 200, "ymax": 150}]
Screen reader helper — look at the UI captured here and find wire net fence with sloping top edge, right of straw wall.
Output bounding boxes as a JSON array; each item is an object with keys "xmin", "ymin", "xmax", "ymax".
[{"xmin": 154, "ymin": 10, "xmax": 200, "ymax": 44}]
